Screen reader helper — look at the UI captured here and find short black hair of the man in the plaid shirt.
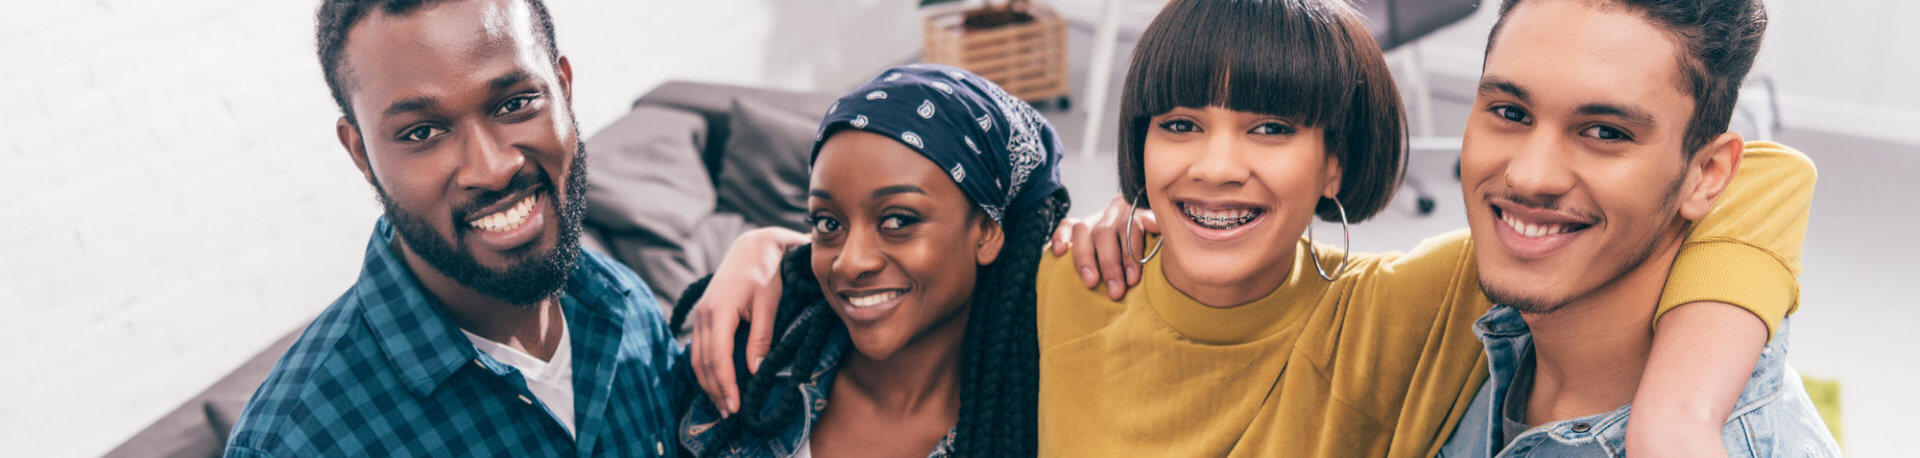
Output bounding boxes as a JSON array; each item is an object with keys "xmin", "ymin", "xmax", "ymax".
[{"xmin": 313, "ymin": 0, "xmax": 561, "ymax": 125}]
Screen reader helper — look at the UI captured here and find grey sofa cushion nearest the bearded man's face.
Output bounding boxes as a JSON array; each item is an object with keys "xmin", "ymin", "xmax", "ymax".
[{"xmin": 588, "ymin": 105, "xmax": 716, "ymax": 245}]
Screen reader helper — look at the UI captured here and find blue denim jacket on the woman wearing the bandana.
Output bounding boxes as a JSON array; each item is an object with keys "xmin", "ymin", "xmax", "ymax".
[{"xmin": 680, "ymin": 318, "xmax": 954, "ymax": 458}]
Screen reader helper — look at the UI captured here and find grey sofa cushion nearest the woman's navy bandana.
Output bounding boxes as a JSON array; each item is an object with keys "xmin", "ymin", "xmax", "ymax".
[{"xmin": 716, "ymin": 98, "xmax": 820, "ymax": 230}]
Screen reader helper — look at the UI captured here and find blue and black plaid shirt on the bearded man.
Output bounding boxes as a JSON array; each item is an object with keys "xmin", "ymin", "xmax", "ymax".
[{"xmin": 227, "ymin": 218, "xmax": 693, "ymax": 456}]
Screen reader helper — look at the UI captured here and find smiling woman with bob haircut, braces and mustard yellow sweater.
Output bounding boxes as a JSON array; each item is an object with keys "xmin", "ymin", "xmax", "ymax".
[{"xmin": 695, "ymin": 0, "xmax": 1784, "ymax": 456}]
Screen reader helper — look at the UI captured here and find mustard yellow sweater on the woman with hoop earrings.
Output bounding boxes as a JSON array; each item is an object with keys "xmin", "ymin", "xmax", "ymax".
[{"xmin": 1037, "ymin": 142, "xmax": 1814, "ymax": 456}]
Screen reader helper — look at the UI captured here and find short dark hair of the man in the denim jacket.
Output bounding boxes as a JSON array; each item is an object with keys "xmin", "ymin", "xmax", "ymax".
[{"xmin": 1486, "ymin": 0, "xmax": 1766, "ymax": 159}]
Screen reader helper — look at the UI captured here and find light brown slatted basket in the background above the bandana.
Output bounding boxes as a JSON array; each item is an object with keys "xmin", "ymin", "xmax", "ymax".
[{"xmin": 922, "ymin": 2, "xmax": 1068, "ymax": 109}]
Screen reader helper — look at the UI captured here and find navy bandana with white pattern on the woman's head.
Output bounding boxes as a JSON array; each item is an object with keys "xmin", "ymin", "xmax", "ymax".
[{"xmin": 808, "ymin": 63, "xmax": 1062, "ymax": 222}]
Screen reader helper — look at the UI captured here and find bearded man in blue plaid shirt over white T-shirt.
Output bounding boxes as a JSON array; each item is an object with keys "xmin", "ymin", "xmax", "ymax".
[{"xmin": 227, "ymin": 0, "xmax": 691, "ymax": 456}]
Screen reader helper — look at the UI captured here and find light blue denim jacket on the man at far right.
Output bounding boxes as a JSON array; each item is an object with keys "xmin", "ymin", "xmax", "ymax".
[{"xmin": 1440, "ymin": 305, "xmax": 1839, "ymax": 458}]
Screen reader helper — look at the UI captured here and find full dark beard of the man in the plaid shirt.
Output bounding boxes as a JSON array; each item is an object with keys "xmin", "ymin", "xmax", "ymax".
[{"xmin": 374, "ymin": 142, "xmax": 588, "ymax": 305}]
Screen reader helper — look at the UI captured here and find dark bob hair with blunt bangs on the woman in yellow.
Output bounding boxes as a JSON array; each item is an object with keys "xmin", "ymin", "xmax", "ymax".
[{"xmin": 1119, "ymin": 0, "xmax": 1407, "ymax": 222}]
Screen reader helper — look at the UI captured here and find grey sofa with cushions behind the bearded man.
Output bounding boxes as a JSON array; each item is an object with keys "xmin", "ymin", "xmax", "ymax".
[{"xmin": 108, "ymin": 80, "xmax": 833, "ymax": 456}]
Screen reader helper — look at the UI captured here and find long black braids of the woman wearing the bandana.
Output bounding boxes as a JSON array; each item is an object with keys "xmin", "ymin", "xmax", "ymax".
[{"xmin": 674, "ymin": 190, "xmax": 1069, "ymax": 456}]
